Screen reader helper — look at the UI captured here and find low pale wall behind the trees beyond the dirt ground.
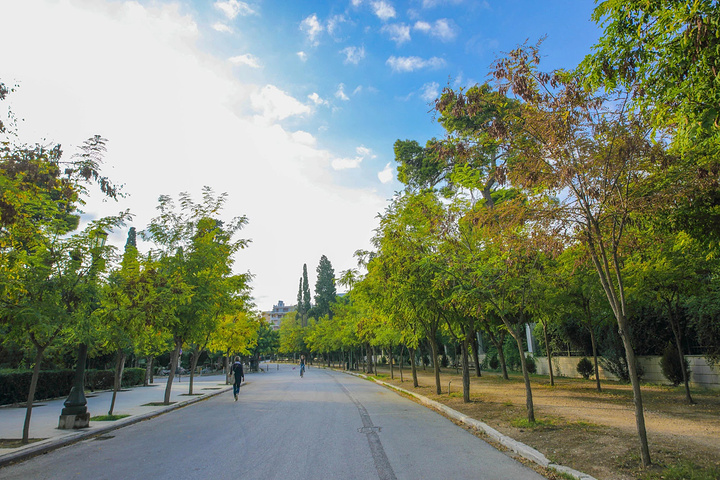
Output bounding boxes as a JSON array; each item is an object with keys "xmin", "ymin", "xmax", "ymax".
[{"xmin": 535, "ymin": 355, "xmax": 720, "ymax": 388}]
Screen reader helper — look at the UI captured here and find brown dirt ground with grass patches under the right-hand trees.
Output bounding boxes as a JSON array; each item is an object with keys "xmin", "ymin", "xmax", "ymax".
[{"xmin": 368, "ymin": 367, "xmax": 720, "ymax": 480}]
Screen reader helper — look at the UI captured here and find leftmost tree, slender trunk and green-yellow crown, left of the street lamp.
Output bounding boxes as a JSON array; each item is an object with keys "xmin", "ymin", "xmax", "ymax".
[{"xmin": 0, "ymin": 103, "xmax": 128, "ymax": 443}]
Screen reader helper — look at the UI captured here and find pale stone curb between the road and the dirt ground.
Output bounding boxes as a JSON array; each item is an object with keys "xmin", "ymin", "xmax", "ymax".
[{"xmin": 344, "ymin": 370, "xmax": 597, "ymax": 480}]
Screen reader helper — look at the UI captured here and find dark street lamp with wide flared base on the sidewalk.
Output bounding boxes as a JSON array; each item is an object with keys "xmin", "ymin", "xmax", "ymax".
[{"xmin": 58, "ymin": 232, "xmax": 107, "ymax": 430}]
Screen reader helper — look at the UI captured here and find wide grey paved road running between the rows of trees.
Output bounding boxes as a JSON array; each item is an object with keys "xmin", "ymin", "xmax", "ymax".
[{"xmin": 0, "ymin": 365, "xmax": 543, "ymax": 480}]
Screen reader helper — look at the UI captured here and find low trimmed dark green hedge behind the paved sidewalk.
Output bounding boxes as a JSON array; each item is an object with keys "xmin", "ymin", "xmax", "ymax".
[{"xmin": 0, "ymin": 368, "xmax": 145, "ymax": 405}]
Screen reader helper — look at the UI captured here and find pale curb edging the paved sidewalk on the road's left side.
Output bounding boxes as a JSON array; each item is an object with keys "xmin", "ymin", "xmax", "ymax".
[{"xmin": 0, "ymin": 386, "xmax": 232, "ymax": 468}]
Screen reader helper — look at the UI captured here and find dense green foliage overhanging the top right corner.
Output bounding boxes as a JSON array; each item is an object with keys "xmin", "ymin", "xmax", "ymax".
[{"xmin": 582, "ymin": 0, "xmax": 720, "ymax": 154}]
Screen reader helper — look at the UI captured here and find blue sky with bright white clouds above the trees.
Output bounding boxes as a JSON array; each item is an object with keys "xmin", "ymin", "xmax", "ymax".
[{"xmin": 0, "ymin": 0, "xmax": 600, "ymax": 310}]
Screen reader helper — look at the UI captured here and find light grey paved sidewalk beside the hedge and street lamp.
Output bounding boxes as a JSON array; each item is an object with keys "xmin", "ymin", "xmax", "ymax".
[{"xmin": 0, "ymin": 374, "xmax": 232, "ymax": 467}]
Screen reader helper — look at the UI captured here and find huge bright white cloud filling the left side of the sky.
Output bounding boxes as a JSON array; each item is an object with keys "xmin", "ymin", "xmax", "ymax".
[{"xmin": 0, "ymin": 0, "xmax": 387, "ymax": 310}]
